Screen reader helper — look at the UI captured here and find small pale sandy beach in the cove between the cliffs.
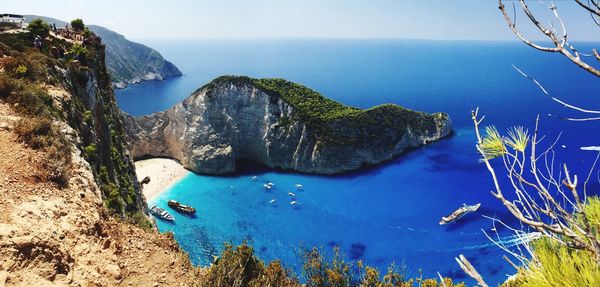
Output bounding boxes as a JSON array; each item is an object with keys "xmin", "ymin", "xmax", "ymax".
[{"xmin": 135, "ymin": 158, "xmax": 191, "ymax": 201}]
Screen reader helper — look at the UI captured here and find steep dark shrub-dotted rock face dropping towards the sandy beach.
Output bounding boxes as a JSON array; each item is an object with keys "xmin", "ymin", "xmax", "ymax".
[{"xmin": 61, "ymin": 36, "xmax": 148, "ymax": 217}]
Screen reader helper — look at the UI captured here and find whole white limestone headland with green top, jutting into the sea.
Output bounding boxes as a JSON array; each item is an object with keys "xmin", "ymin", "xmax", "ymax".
[{"xmin": 123, "ymin": 77, "xmax": 451, "ymax": 174}]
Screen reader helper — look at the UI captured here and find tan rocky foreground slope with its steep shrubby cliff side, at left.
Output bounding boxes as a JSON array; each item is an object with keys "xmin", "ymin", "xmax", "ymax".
[{"xmin": 0, "ymin": 28, "xmax": 196, "ymax": 286}]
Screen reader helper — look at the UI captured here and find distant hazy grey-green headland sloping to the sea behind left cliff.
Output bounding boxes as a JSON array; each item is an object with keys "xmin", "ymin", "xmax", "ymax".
[{"xmin": 25, "ymin": 15, "xmax": 182, "ymax": 88}]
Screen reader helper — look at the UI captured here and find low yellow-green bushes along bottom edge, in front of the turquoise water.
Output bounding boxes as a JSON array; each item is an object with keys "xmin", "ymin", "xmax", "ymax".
[{"xmin": 196, "ymin": 243, "xmax": 465, "ymax": 287}]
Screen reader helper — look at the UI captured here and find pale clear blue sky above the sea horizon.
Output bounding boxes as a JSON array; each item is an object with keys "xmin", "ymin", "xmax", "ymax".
[{"xmin": 0, "ymin": 0, "xmax": 600, "ymax": 41}]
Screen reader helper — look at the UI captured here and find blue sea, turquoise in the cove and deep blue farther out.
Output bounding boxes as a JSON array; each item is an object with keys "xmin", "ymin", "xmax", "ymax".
[{"xmin": 117, "ymin": 39, "xmax": 600, "ymax": 284}]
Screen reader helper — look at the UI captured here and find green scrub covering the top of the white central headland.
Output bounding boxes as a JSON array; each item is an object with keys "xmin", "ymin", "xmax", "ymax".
[{"xmin": 201, "ymin": 76, "xmax": 448, "ymax": 146}]
